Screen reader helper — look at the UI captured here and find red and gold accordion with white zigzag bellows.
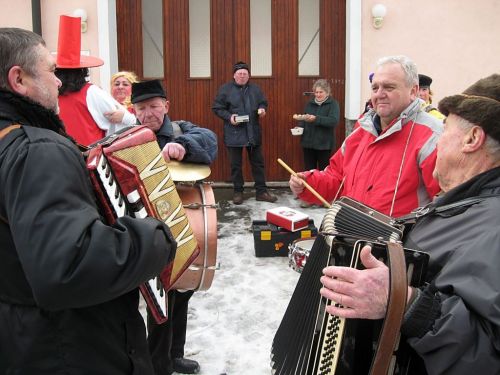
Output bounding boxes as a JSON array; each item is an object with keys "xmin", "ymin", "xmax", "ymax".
[{"xmin": 86, "ymin": 126, "xmax": 199, "ymax": 324}]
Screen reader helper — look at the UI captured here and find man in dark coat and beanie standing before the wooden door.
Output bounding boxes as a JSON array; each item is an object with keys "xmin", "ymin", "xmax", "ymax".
[{"xmin": 212, "ymin": 61, "xmax": 277, "ymax": 204}]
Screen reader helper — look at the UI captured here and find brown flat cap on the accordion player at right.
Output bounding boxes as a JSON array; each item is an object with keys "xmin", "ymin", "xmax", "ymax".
[{"xmin": 438, "ymin": 74, "xmax": 500, "ymax": 142}]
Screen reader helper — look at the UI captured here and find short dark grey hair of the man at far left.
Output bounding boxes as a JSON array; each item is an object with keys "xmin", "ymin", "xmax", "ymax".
[{"xmin": 0, "ymin": 27, "xmax": 45, "ymax": 91}]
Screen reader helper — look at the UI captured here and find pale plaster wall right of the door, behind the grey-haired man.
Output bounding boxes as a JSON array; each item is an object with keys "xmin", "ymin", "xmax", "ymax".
[{"xmin": 362, "ymin": 0, "xmax": 500, "ymax": 111}]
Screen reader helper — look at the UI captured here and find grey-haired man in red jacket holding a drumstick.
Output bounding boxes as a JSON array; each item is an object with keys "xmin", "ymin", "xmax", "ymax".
[{"xmin": 289, "ymin": 56, "xmax": 442, "ymax": 217}]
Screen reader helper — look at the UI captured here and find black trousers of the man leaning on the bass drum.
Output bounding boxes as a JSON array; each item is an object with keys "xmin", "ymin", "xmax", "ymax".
[{"xmin": 147, "ymin": 290, "xmax": 194, "ymax": 375}]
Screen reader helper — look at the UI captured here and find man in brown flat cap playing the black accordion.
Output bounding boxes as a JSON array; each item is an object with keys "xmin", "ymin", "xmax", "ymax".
[{"xmin": 321, "ymin": 74, "xmax": 500, "ymax": 375}]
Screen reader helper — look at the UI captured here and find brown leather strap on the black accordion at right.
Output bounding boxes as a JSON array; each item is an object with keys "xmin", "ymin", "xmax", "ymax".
[{"xmin": 370, "ymin": 242, "xmax": 408, "ymax": 375}]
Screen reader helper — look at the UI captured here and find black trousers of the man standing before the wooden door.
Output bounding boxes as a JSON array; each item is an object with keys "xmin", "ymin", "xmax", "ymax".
[{"xmin": 227, "ymin": 146, "xmax": 267, "ymax": 194}]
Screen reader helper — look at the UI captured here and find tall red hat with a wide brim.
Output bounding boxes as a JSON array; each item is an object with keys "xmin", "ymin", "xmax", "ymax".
[{"xmin": 56, "ymin": 16, "xmax": 104, "ymax": 69}]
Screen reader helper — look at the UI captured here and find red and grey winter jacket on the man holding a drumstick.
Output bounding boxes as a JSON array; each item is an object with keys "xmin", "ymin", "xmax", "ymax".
[{"xmin": 299, "ymin": 99, "xmax": 443, "ymax": 217}]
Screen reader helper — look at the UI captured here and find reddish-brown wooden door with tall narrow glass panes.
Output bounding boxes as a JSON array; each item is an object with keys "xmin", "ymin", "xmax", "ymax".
[{"xmin": 116, "ymin": 0, "xmax": 346, "ymax": 182}]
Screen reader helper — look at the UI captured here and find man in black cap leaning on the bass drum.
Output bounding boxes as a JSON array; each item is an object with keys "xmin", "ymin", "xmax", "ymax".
[{"xmin": 131, "ymin": 80, "xmax": 217, "ymax": 375}]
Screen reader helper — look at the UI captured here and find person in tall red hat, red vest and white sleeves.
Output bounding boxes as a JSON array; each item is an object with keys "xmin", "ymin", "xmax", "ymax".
[{"xmin": 55, "ymin": 15, "xmax": 137, "ymax": 146}]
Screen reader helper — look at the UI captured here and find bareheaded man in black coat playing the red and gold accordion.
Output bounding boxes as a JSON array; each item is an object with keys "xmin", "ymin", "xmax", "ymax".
[{"xmin": 0, "ymin": 28, "xmax": 176, "ymax": 375}]
